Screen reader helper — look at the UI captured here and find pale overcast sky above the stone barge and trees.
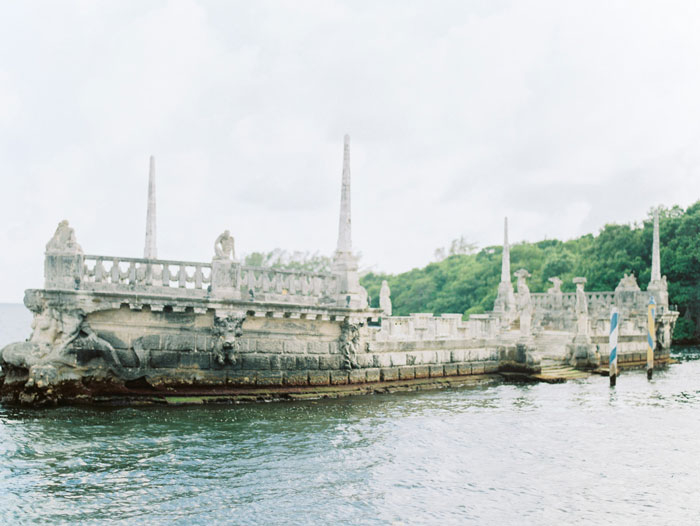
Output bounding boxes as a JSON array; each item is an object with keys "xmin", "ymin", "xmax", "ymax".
[{"xmin": 0, "ymin": 0, "xmax": 700, "ymax": 302}]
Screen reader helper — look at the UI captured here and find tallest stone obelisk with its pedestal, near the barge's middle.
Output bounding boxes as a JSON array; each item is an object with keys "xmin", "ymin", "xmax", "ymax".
[{"xmin": 332, "ymin": 135, "xmax": 368, "ymax": 309}]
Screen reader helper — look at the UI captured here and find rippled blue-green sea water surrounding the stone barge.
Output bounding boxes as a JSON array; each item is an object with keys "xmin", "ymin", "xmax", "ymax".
[{"xmin": 0, "ymin": 305, "xmax": 700, "ymax": 526}]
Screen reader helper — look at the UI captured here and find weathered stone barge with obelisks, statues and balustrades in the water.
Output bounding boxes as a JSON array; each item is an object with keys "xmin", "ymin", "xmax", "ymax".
[{"xmin": 0, "ymin": 137, "xmax": 678, "ymax": 405}]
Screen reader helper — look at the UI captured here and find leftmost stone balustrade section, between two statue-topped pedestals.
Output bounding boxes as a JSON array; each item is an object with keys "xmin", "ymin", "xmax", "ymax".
[{"xmin": 80, "ymin": 256, "xmax": 211, "ymax": 295}]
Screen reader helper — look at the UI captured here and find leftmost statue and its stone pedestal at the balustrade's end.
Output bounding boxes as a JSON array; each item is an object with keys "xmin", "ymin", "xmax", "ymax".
[{"xmin": 44, "ymin": 220, "xmax": 84, "ymax": 290}]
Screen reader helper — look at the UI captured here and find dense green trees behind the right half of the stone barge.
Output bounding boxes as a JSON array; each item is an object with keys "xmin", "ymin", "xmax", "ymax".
[{"xmin": 361, "ymin": 201, "xmax": 700, "ymax": 341}]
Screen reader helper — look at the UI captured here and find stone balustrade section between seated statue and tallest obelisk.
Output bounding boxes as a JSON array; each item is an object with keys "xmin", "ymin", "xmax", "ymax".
[{"xmin": 240, "ymin": 267, "xmax": 338, "ymax": 304}]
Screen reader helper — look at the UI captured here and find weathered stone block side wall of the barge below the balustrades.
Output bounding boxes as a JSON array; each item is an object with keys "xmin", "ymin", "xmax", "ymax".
[{"xmin": 83, "ymin": 306, "xmax": 504, "ymax": 386}]
